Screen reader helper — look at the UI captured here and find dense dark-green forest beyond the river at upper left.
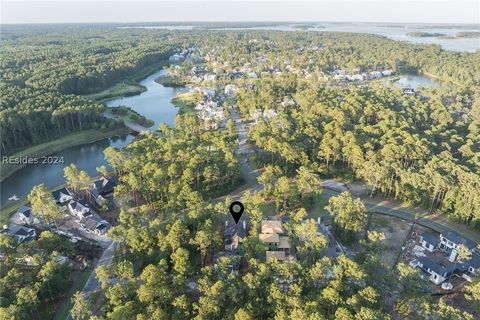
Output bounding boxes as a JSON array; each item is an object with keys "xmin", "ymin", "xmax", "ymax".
[{"xmin": 0, "ymin": 27, "xmax": 171, "ymax": 154}]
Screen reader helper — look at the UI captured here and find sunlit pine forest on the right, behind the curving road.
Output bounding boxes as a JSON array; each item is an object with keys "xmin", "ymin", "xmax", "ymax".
[{"xmin": 237, "ymin": 81, "xmax": 480, "ymax": 226}]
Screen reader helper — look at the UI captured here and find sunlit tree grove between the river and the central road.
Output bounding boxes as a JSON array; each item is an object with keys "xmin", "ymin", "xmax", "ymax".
[{"xmin": 104, "ymin": 114, "xmax": 240, "ymax": 213}]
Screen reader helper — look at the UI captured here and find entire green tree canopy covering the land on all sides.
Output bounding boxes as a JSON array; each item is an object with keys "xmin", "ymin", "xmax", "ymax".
[{"xmin": 0, "ymin": 25, "xmax": 480, "ymax": 320}]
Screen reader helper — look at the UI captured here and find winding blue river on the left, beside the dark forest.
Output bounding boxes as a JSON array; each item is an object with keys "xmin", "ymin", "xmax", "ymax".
[{"xmin": 0, "ymin": 70, "xmax": 184, "ymax": 207}]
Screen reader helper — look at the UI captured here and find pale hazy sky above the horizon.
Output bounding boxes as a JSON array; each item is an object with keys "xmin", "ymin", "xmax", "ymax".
[{"xmin": 0, "ymin": 0, "xmax": 480, "ymax": 23}]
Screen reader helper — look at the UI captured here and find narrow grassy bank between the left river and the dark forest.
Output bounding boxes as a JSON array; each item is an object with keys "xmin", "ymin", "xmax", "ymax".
[{"xmin": 0, "ymin": 128, "xmax": 129, "ymax": 180}]
